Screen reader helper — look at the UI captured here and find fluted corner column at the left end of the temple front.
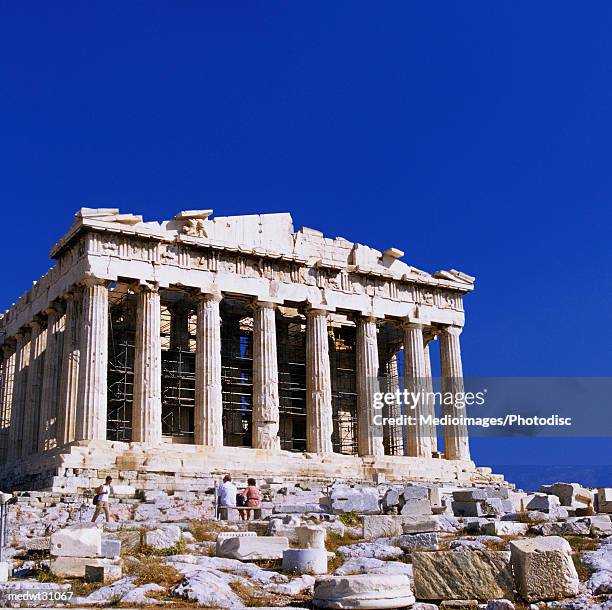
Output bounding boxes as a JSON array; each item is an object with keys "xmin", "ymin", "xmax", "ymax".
[{"xmin": 76, "ymin": 277, "xmax": 108, "ymax": 440}]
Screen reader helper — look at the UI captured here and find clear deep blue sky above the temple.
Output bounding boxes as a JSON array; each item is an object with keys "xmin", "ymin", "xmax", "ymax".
[{"xmin": 0, "ymin": 1, "xmax": 612, "ymax": 480}]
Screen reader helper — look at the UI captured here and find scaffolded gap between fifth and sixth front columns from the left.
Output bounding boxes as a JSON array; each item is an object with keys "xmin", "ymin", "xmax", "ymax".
[{"xmin": 329, "ymin": 325, "xmax": 357, "ymax": 455}]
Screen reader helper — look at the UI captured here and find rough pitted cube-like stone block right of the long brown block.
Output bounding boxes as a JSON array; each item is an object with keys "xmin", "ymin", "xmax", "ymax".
[{"xmin": 510, "ymin": 536, "xmax": 578, "ymax": 602}]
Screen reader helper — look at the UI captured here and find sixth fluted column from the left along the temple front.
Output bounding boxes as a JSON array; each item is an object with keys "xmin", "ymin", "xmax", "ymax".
[{"xmin": 357, "ymin": 317, "xmax": 385, "ymax": 455}]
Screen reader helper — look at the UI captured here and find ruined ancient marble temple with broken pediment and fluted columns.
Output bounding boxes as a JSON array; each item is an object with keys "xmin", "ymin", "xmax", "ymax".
[{"xmin": 0, "ymin": 208, "xmax": 495, "ymax": 489}]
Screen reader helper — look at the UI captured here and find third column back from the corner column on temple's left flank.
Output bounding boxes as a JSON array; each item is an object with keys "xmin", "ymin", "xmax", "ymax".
[{"xmin": 22, "ymin": 319, "xmax": 47, "ymax": 455}]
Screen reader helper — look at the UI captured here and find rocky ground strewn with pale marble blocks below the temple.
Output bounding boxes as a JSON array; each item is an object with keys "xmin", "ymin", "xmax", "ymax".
[{"xmin": 0, "ymin": 482, "xmax": 612, "ymax": 610}]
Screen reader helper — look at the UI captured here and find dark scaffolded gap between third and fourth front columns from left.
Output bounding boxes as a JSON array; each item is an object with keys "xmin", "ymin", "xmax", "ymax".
[{"xmin": 221, "ymin": 297, "xmax": 253, "ymax": 447}]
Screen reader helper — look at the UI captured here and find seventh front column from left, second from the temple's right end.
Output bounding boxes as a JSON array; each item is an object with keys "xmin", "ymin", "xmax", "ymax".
[{"xmin": 404, "ymin": 323, "xmax": 431, "ymax": 458}]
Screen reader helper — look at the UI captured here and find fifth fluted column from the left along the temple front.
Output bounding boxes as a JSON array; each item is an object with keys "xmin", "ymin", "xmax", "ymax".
[{"xmin": 306, "ymin": 309, "xmax": 334, "ymax": 453}]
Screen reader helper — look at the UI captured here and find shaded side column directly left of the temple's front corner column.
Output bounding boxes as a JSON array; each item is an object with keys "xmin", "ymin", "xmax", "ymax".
[{"xmin": 56, "ymin": 288, "xmax": 83, "ymax": 447}]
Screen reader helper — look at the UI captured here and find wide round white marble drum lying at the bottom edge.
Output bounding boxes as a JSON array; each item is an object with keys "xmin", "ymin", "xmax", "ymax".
[{"xmin": 313, "ymin": 574, "xmax": 415, "ymax": 609}]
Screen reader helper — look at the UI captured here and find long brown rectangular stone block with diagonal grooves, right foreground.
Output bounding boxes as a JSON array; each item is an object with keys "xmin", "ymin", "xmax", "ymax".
[{"xmin": 412, "ymin": 551, "xmax": 514, "ymax": 601}]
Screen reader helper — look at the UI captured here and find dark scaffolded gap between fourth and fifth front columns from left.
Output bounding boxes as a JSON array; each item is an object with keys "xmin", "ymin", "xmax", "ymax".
[{"xmin": 276, "ymin": 308, "xmax": 306, "ymax": 452}]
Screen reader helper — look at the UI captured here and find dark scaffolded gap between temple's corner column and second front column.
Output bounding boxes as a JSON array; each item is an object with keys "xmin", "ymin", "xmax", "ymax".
[{"xmin": 106, "ymin": 288, "xmax": 136, "ymax": 441}]
